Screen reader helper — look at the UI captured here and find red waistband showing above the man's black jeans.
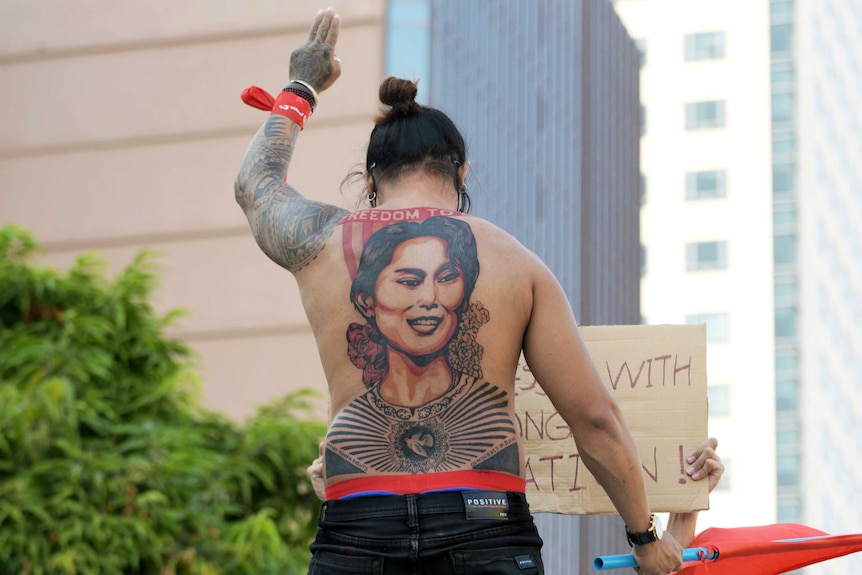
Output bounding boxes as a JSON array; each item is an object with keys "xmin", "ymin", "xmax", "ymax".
[{"xmin": 326, "ymin": 469, "xmax": 527, "ymax": 499}]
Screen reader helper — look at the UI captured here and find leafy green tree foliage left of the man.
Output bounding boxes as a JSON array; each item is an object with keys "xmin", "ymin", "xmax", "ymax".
[{"xmin": 0, "ymin": 226, "xmax": 324, "ymax": 575}]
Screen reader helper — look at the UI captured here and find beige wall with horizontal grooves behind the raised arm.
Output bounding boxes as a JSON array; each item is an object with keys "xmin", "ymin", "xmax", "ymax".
[{"xmin": 0, "ymin": 0, "xmax": 385, "ymax": 424}]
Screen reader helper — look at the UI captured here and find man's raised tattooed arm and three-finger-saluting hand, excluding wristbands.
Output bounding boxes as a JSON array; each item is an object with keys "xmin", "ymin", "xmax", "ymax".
[{"xmin": 234, "ymin": 9, "xmax": 346, "ymax": 273}]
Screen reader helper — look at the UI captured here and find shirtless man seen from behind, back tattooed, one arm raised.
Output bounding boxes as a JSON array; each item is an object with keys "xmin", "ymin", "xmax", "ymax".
[{"xmin": 236, "ymin": 9, "xmax": 681, "ymax": 575}]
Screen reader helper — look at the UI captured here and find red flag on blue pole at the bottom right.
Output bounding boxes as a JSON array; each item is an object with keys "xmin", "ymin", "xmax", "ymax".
[{"xmin": 677, "ymin": 523, "xmax": 862, "ymax": 575}]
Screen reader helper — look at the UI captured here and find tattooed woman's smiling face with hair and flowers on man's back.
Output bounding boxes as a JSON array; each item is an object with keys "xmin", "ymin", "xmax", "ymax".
[{"xmin": 347, "ymin": 217, "xmax": 489, "ymax": 394}]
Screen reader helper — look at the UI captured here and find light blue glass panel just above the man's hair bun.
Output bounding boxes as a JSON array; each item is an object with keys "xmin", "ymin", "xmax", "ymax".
[{"xmin": 386, "ymin": 0, "xmax": 431, "ymax": 102}]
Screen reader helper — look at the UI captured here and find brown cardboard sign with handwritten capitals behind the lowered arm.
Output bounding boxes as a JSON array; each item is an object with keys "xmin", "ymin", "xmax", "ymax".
[{"xmin": 515, "ymin": 325, "xmax": 709, "ymax": 514}]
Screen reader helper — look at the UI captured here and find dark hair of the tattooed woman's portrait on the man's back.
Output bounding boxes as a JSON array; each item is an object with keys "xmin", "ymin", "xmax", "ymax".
[{"xmin": 350, "ymin": 216, "xmax": 479, "ymax": 322}]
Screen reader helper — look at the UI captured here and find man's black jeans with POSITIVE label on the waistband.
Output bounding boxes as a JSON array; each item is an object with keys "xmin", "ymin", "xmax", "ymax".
[{"xmin": 308, "ymin": 491, "xmax": 545, "ymax": 575}]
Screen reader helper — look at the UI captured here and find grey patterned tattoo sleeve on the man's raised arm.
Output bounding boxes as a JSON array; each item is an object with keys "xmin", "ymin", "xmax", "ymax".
[{"xmin": 235, "ymin": 115, "xmax": 347, "ymax": 273}]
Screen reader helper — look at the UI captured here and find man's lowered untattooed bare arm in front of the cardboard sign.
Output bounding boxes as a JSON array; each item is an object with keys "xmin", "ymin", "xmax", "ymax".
[{"xmin": 523, "ymin": 264, "xmax": 682, "ymax": 575}]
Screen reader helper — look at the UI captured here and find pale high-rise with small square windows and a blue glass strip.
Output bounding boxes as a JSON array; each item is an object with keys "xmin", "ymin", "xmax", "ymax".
[{"xmin": 614, "ymin": 0, "xmax": 862, "ymax": 575}]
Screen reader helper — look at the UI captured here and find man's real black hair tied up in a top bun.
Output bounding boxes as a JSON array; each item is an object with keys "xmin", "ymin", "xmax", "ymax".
[{"xmin": 365, "ymin": 76, "xmax": 471, "ymax": 212}]
